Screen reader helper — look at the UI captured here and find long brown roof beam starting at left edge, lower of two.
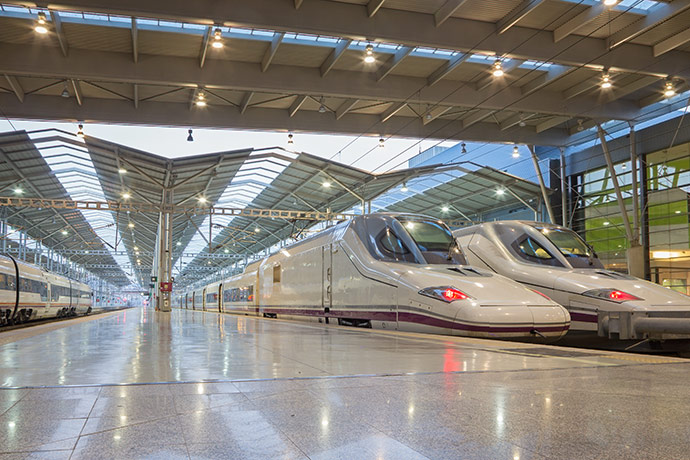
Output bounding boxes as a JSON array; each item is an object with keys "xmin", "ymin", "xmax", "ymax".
[{"xmin": 0, "ymin": 43, "xmax": 644, "ymax": 120}]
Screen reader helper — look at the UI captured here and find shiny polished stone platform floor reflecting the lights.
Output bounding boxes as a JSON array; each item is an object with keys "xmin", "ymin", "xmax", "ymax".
[{"xmin": 0, "ymin": 308, "xmax": 690, "ymax": 460}]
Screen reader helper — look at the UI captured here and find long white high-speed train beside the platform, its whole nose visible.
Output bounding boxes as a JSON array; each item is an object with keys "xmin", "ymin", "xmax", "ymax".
[{"xmin": 178, "ymin": 214, "xmax": 570, "ymax": 341}]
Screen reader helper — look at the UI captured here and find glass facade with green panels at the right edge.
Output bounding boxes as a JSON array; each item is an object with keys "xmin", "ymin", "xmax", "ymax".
[{"xmin": 570, "ymin": 140, "xmax": 690, "ymax": 294}]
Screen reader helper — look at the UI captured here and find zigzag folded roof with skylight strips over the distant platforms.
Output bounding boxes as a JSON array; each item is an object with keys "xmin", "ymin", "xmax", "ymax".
[{"xmin": 0, "ymin": 130, "xmax": 540, "ymax": 286}]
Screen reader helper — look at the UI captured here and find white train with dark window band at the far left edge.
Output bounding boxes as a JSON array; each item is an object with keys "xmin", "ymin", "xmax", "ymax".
[{"xmin": 0, "ymin": 255, "xmax": 92, "ymax": 326}]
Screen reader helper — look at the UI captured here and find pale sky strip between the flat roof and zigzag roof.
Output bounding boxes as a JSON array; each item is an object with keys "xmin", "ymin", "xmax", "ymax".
[{"xmin": 0, "ymin": 120, "xmax": 456, "ymax": 173}]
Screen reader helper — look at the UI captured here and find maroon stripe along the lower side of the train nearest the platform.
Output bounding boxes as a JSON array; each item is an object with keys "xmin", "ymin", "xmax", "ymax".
[{"xmin": 249, "ymin": 308, "xmax": 570, "ymax": 333}]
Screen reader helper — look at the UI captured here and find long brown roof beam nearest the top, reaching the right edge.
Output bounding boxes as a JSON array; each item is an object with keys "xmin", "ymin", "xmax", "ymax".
[{"xmin": 35, "ymin": 0, "xmax": 690, "ymax": 79}]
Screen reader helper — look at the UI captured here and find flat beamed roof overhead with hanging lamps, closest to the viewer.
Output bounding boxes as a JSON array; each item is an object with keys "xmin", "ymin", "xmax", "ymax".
[{"xmin": 0, "ymin": 0, "xmax": 690, "ymax": 146}]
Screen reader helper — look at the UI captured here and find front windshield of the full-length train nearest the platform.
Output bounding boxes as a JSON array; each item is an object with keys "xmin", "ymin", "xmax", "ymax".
[{"xmin": 398, "ymin": 217, "xmax": 467, "ymax": 265}]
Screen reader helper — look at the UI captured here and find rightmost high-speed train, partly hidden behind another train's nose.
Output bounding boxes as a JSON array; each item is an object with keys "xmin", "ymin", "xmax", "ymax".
[{"xmin": 453, "ymin": 221, "xmax": 690, "ymax": 341}]
